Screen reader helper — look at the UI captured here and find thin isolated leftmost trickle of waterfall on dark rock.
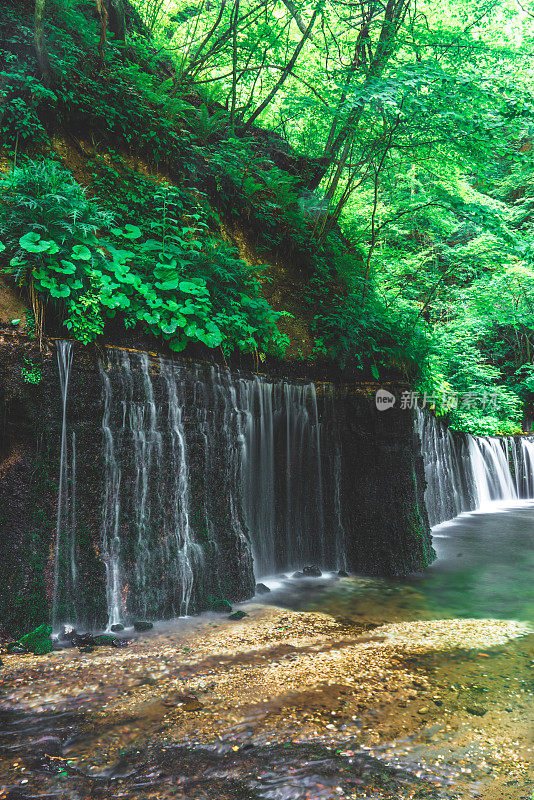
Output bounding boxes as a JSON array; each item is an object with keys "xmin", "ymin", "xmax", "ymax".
[{"xmin": 52, "ymin": 341, "xmax": 78, "ymax": 630}]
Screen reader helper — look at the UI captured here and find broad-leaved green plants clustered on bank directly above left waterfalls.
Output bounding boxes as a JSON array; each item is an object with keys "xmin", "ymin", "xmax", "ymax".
[{"xmin": 0, "ymin": 160, "xmax": 284, "ymax": 352}]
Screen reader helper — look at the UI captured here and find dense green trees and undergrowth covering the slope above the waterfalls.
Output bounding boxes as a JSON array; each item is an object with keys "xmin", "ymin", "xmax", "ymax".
[{"xmin": 0, "ymin": 0, "xmax": 534, "ymax": 433}]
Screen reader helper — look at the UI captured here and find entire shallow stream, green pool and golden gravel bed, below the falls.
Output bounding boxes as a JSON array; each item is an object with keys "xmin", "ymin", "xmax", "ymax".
[{"xmin": 0, "ymin": 503, "xmax": 534, "ymax": 800}]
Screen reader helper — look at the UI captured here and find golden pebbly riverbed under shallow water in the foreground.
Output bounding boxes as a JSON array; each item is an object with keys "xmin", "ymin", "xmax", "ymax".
[{"xmin": 0, "ymin": 604, "xmax": 534, "ymax": 800}]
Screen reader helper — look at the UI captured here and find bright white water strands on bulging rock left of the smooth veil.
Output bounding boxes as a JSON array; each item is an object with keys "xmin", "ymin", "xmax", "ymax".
[{"xmin": 101, "ymin": 351, "xmax": 203, "ymax": 625}]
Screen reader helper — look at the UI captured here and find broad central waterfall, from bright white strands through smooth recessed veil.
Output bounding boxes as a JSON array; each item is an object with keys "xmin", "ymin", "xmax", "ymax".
[{"xmin": 91, "ymin": 350, "xmax": 338, "ymax": 626}]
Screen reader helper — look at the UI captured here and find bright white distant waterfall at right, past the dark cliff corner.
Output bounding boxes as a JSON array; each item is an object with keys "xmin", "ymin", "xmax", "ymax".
[{"xmin": 415, "ymin": 409, "xmax": 534, "ymax": 526}]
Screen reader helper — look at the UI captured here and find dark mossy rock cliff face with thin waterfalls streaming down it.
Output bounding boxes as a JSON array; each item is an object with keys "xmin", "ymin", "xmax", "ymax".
[{"xmin": 0, "ymin": 333, "xmax": 433, "ymax": 632}]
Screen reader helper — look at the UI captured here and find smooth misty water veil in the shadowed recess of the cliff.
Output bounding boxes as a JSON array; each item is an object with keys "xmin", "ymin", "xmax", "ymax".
[{"xmin": 239, "ymin": 377, "xmax": 330, "ymax": 577}]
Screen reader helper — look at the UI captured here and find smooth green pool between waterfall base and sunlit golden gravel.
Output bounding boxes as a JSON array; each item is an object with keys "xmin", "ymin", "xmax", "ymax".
[{"xmin": 262, "ymin": 501, "xmax": 534, "ymax": 624}]
